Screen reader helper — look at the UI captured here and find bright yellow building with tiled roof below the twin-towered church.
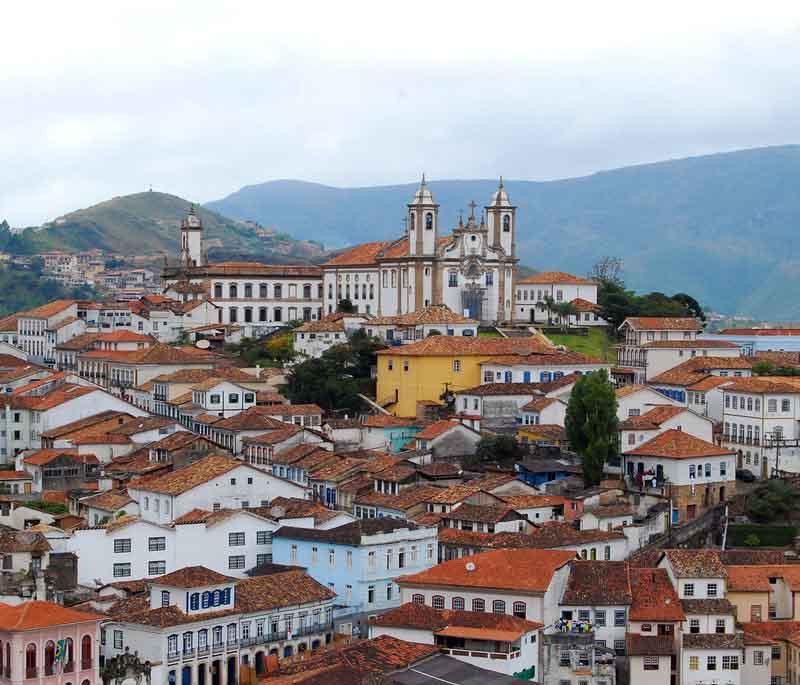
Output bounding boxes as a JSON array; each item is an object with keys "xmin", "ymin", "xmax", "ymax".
[{"xmin": 376, "ymin": 335, "xmax": 556, "ymax": 416}]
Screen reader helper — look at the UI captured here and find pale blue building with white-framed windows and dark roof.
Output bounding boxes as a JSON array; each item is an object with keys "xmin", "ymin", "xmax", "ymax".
[{"xmin": 272, "ymin": 518, "xmax": 437, "ymax": 636}]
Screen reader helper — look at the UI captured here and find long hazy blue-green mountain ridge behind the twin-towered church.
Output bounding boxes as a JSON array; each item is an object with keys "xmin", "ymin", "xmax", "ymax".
[{"xmin": 205, "ymin": 145, "xmax": 800, "ymax": 320}]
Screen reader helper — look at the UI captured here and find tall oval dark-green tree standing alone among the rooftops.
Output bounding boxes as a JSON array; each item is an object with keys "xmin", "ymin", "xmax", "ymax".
[{"xmin": 565, "ymin": 369, "xmax": 619, "ymax": 485}]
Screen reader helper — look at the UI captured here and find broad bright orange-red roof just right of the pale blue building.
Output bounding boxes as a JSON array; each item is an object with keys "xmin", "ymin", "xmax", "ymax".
[{"xmin": 397, "ymin": 549, "xmax": 575, "ymax": 594}]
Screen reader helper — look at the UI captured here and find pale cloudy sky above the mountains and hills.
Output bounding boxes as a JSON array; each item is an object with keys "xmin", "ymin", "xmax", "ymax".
[{"xmin": 0, "ymin": 0, "xmax": 800, "ymax": 226}]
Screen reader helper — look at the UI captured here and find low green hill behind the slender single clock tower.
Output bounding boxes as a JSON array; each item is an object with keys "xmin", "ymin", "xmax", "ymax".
[{"xmin": 0, "ymin": 192, "xmax": 322, "ymax": 261}]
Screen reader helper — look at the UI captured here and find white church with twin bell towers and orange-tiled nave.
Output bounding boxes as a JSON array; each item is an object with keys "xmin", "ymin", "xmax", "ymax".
[{"xmin": 322, "ymin": 177, "xmax": 517, "ymax": 323}]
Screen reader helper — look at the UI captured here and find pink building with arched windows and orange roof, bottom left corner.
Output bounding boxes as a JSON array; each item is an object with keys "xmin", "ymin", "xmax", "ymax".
[{"xmin": 0, "ymin": 600, "xmax": 105, "ymax": 685}]
